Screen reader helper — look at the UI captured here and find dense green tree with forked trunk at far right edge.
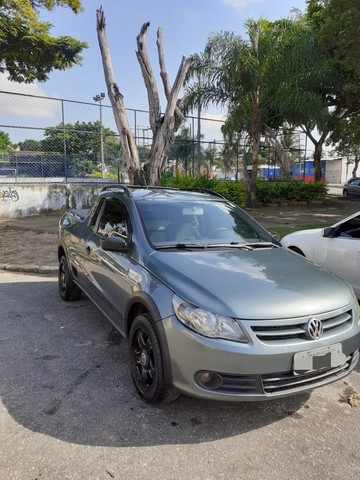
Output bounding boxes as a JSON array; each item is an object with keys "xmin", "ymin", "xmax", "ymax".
[{"xmin": 282, "ymin": 0, "xmax": 360, "ymax": 181}]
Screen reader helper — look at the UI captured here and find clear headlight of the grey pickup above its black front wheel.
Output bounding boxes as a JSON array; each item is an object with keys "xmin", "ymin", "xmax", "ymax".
[{"xmin": 172, "ymin": 295, "xmax": 249, "ymax": 343}]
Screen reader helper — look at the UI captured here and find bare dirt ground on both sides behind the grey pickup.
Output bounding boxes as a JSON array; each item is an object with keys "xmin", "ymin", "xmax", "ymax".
[{"xmin": 0, "ymin": 197, "xmax": 360, "ymax": 270}]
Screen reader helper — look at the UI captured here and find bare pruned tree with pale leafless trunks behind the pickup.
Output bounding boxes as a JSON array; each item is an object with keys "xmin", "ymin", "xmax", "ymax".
[{"xmin": 96, "ymin": 8, "xmax": 192, "ymax": 185}]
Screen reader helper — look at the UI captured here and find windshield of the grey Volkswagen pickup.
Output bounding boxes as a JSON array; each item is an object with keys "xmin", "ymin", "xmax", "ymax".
[{"xmin": 136, "ymin": 199, "xmax": 273, "ymax": 247}]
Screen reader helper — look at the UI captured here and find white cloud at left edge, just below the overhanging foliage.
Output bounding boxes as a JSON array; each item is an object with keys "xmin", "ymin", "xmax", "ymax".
[{"xmin": 0, "ymin": 73, "xmax": 59, "ymax": 118}]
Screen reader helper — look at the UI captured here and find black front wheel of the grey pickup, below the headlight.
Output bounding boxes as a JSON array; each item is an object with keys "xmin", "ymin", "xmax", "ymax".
[{"xmin": 129, "ymin": 314, "xmax": 178, "ymax": 404}]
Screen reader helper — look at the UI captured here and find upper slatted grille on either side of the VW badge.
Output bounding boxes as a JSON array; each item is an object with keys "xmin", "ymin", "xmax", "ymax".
[{"xmin": 251, "ymin": 310, "xmax": 352, "ymax": 343}]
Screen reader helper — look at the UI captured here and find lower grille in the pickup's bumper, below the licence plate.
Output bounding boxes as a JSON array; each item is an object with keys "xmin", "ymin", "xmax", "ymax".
[{"xmin": 261, "ymin": 350, "xmax": 359, "ymax": 395}]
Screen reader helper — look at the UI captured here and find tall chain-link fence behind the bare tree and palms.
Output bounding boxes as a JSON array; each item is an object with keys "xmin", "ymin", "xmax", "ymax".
[{"xmin": 0, "ymin": 91, "xmax": 312, "ymax": 183}]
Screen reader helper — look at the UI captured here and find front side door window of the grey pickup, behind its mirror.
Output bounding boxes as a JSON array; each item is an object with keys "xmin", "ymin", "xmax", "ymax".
[{"xmin": 97, "ymin": 200, "xmax": 129, "ymax": 240}]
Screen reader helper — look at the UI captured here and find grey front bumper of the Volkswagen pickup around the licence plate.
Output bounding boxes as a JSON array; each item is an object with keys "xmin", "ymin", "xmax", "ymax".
[{"xmin": 163, "ymin": 316, "xmax": 360, "ymax": 401}]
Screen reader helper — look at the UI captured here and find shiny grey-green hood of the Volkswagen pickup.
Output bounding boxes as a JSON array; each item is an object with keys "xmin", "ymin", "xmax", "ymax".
[{"xmin": 146, "ymin": 248, "xmax": 352, "ymax": 319}]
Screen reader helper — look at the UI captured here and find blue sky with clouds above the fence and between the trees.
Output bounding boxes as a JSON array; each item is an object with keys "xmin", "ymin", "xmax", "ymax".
[{"xmin": 0, "ymin": 0, "xmax": 306, "ymax": 144}]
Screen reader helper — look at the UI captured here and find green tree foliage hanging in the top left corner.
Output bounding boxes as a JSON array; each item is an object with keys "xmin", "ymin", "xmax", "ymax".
[{"xmin": 0, "ymin": 0, "xmax": 87, "ymax": 83}]
